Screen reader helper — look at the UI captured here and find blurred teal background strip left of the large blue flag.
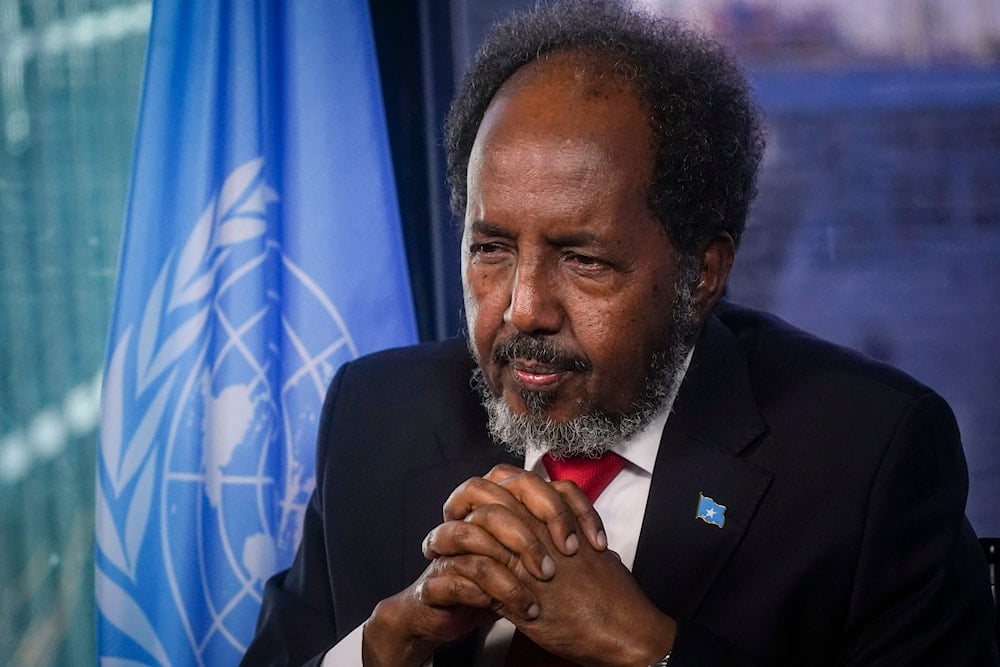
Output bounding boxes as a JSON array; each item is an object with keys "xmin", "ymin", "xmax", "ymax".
[{"xmin": 0, "ymin": 0, "xmax": 150, "ymax": 665}]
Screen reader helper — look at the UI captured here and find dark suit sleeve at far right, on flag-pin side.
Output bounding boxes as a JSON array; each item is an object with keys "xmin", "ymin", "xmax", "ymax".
[{"xmin": 838, "ymin": 393, "xmax": 998, "ymax": 666}]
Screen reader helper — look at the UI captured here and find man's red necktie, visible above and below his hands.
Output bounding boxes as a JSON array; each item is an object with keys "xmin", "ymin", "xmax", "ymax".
[{"xmin": 507, "ymin": 452, "xmax": 625, "ymax": 667}]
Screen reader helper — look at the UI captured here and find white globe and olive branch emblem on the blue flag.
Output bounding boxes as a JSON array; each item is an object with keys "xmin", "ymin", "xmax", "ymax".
[{"xmin": 96, "ymin": 158, "xmax": 357, "ymax": 665}]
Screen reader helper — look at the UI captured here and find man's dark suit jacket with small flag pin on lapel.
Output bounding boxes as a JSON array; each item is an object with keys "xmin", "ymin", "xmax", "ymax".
[{"xmin": 245, "ymin": 305, "xmax": 998, "ymax": 667}]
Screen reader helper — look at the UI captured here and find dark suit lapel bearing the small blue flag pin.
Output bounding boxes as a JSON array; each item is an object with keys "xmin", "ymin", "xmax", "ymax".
[{"xmin": 633, "ymin": 315, "xmax": 771, "ymax": 618}]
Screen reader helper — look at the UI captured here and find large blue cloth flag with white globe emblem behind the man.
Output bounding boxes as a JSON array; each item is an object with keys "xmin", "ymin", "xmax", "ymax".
[{"xmin": 96, "ymin": 0, "xmax": 416, "ymax": 667}]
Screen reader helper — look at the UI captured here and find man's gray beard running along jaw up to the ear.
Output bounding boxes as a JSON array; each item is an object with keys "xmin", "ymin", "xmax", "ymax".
[{"xmin": 472, "ymin": 258, "xmax": 699, "ymax": 458}]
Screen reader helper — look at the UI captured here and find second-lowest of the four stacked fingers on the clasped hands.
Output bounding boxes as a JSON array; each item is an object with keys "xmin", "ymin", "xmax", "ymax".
[{"xmin": 422, "ymin": 516, "xmax": 556, "ymax": 581}]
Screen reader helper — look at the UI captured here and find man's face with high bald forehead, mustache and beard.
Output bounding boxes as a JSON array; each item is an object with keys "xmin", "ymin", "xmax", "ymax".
[{"xmin": 462, "ymin": 56, "xmax": 692, "ymax": 454}]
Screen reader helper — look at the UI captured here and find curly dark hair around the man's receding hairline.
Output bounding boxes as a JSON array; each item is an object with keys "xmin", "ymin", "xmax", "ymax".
[{"xmin": 445, "ymin": 0, "xmax": 764, "ymax": 255}]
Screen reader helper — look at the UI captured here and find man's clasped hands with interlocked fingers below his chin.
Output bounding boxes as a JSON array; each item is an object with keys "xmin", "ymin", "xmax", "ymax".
[{"xmin": 363, "ymin": 465, "xmax": 676, "ymax": 667}]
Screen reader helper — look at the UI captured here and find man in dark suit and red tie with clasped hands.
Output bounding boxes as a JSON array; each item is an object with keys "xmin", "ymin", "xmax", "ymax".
[{"xmin": 246, "ymin": 2, "xmax": 997, "ymax": 667}]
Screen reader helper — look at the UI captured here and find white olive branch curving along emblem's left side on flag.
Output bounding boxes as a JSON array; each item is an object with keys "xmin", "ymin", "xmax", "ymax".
[{"xmin": 95, "ymin": 157, "xmax": 277, "ymax": 665}]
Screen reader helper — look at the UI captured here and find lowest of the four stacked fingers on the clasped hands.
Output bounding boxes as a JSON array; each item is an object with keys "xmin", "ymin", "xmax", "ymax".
[{"xmin": 416, "ymin": 555, "xmax": 541, "ymax": 621}]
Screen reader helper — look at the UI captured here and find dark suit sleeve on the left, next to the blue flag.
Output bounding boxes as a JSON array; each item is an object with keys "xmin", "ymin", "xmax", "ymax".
[{"xmin": 241, "ymin": 364, "xmax": 347, "ymax": 667}]
